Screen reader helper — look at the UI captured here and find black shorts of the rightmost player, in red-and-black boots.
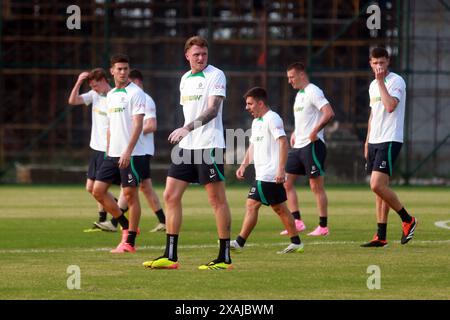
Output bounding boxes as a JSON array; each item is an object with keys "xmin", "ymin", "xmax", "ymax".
[{"xmin": 366, "ymin": 142, "xmax": 403, "ymax": 176}]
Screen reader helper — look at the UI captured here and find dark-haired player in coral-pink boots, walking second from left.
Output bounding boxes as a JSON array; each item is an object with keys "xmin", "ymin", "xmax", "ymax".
[{"xmin": 93, "ymin": 54, "xmax": 149, "ymax": 253}]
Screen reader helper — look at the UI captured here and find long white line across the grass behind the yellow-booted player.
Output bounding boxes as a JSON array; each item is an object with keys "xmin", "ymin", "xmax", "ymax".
[{"xmin": 0, "ymin": 240, "xmax": 450, "ymax": 254}]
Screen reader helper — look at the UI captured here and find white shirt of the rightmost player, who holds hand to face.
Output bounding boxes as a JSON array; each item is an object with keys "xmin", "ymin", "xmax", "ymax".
[{"xmin": 369, "ymin": 72, "xmax": 406, "ymax": 143}]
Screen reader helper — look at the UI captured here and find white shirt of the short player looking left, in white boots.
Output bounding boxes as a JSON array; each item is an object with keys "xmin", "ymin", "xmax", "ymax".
[{"xmin": 250, "ymin": 110, "xmax": 286, "ymax": 182}]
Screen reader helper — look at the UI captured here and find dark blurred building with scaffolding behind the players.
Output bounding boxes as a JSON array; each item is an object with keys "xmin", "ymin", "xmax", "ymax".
[{"xmin": 0, "ymin": 0, "xmax": 450, "ymax": 182}]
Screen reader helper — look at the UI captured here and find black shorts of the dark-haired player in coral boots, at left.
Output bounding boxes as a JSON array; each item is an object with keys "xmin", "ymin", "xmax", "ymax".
[{"xmin": 97, "ymin": 155, "xmax": 150, "ymax": 187}]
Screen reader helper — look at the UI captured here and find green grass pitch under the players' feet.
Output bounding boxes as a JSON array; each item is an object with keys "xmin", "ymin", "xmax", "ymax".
[{"xmin": 0, "ymin": 186, "xmax": 450, "ymax": 300}]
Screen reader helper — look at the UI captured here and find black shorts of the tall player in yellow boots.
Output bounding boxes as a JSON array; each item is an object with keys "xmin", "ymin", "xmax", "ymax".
[{"xmin": 167, "ymin": 149, "xmax": 225, "ymax": 185}]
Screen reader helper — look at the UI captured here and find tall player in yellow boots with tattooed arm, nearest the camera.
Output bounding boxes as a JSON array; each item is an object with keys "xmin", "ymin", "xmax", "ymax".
[{"xmin": 143, "ymin": 36, "xmax": 232, "ymax": 270}]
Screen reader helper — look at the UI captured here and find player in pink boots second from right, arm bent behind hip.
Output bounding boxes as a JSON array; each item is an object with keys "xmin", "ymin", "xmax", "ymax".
[{"xmin": 281, "ymin": 62, "xmax": 334, "ymax": 236}]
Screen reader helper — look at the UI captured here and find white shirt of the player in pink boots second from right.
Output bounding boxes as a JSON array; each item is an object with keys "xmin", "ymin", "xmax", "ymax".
[{"xmin": 294, "ymin": 83, "xmax": 329, "ymax": 148}]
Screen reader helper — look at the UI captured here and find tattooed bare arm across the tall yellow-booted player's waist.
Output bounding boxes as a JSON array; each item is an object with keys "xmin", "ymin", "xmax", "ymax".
[{"xmin": 168, "ymin": 96, "xmax": 223, "ymax": 144}]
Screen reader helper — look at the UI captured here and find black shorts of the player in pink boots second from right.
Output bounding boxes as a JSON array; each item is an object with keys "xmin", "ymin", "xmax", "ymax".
[{"xmin": 286, "ymin": 139, "xmax": 327, "ymax": 178}]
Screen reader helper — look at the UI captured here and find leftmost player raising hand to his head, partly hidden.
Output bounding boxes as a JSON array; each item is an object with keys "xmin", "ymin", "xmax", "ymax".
[{"xmin": 68, "ymin": 68, "xmax": 118, "ymax": 231}]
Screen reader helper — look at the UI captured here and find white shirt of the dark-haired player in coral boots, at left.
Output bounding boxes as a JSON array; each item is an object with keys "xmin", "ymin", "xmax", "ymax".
[{"xmin": 106, "ymin": 82, "xmax": 146, "ymax": 157}]
